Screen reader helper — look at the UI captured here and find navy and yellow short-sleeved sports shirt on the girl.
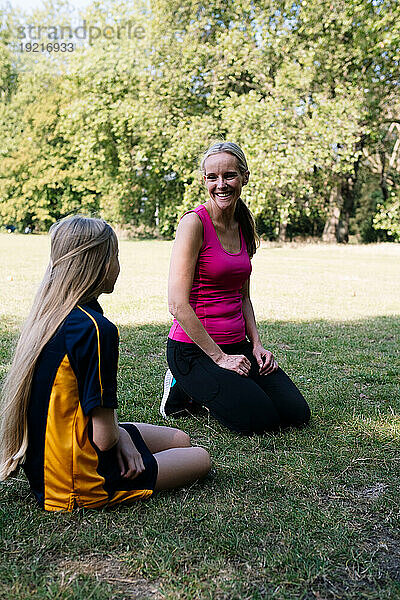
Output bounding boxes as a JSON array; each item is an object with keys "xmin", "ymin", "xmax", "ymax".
[{"xmin": 23, "ymin": 300, "xmax": 153, "ymax": 511}]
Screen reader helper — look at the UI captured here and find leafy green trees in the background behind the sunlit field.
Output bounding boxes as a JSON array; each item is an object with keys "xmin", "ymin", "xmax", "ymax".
[{"xmin": 0, "ymin": 0, "xmax": 400, "ymax": 239}]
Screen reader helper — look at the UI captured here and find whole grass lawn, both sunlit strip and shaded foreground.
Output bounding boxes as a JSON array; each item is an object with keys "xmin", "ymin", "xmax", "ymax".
[{"xmin": 0, "ymin": 235, "xmax": 400, "ymax": 600}]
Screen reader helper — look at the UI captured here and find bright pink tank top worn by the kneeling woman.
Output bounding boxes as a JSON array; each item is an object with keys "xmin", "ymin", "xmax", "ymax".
[{"xmin": 168, "ymin": 204, "xmax": 251, "ymax": 344}]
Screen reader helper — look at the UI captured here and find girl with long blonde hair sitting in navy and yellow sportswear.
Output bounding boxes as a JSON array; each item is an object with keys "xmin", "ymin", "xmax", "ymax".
[{"xmin": 0, "ymin": 216, "xmax": 210, "ymax": 511}]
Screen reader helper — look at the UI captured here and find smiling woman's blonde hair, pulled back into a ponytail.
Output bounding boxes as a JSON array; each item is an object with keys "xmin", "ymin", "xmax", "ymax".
[{"xmin": 200, "ymin": 142, "xmax": 260, "ymax": 257}]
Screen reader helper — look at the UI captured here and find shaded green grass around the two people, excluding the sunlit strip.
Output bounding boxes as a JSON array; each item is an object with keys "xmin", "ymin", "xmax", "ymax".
[{"xmin": 0, "ymin": 317, "xmax": 400, "ymax": 600}]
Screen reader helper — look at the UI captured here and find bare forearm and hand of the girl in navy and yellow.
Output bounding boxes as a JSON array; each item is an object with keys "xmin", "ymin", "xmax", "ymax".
[{"xmin": 91, "ymin": 406, "xmax": 144, "ymax": 479}]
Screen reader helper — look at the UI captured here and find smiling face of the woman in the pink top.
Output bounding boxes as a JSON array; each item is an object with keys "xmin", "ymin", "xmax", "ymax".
[{"xmin": 204, "ymin": 152, "xmax": 248, "ymax": 210}]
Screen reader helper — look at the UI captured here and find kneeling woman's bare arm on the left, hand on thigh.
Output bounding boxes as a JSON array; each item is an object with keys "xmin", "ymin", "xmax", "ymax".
[{"xmin": 168, "ymin": 213, "xmax": 250, "ymax": 375}]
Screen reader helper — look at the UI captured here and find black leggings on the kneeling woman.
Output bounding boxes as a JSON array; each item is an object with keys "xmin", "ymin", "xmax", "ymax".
[{"xmin": 167, "ymin": 338, "xmax": 310, "ymax": 435}]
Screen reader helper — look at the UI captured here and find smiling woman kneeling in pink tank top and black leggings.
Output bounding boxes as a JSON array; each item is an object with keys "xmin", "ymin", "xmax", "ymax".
[{"xmin": 160, "ymin": 142, "xmax": 310, "ymax": 434}]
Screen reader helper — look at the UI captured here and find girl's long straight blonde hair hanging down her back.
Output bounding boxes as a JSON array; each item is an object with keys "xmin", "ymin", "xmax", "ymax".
[{"xmin": 0, "ymin": 215, "xmax": 118, "ymax": 481}]
